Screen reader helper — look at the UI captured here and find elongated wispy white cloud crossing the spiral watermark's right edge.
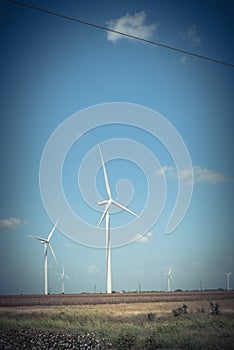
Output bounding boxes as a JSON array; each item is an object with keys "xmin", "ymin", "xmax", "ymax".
[{"xmin": 156, "ymin": 165, "xmax": 228, "ymax": 185}]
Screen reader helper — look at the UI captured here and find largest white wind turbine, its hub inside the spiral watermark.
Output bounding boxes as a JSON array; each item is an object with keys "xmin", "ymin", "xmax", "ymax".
[{"xmin": 97, "ymin": 146, "xmax": 138, "ymax": 293}]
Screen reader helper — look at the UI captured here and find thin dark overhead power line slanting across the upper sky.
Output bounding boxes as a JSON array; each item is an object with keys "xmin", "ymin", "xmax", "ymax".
[{"xmin": 7, "ymin": 0, "xmax": 234, "ymax": 67}]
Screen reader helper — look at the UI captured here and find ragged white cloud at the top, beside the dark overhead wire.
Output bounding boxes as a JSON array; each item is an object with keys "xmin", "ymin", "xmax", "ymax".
[{"xmin": 107, "ymin": 11, "xmax": 157, "ymax": 42}]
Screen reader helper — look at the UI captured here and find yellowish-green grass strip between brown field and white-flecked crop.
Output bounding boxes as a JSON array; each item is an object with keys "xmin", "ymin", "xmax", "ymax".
[{"xmin": 0, "ymin": 304, "xmax": 234, "ymax": 350}]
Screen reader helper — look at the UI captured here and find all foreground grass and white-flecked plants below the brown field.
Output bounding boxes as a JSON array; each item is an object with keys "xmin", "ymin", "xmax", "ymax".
[{"xmin": 0, "ymin": 301, "xmax": 234, "ymax": 350}]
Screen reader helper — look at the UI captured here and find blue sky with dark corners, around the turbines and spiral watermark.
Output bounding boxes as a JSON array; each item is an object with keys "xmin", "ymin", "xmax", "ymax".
[{"xmin": 0, "ymin": 0, "xmax": 234, "ymax": 294}]
